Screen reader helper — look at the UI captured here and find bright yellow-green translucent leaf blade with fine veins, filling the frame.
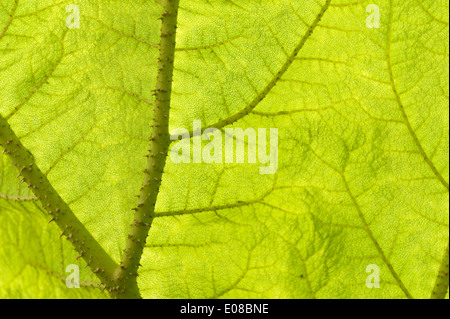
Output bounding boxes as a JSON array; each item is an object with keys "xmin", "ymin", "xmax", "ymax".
[{"xmin": 0, "ymin": 0, "xmax": 449, "ymax": 298}]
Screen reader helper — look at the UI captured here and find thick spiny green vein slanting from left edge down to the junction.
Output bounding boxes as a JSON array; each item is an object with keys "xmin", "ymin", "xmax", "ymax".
[{"xmin": 0, "ymin": 116, "xmax": 117, "ymax": 287}]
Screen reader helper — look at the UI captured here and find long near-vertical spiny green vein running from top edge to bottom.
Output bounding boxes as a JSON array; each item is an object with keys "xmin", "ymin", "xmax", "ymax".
[{"xmin": 113, "ymin": 0, "xmax": 179, "ymax": 298}]
